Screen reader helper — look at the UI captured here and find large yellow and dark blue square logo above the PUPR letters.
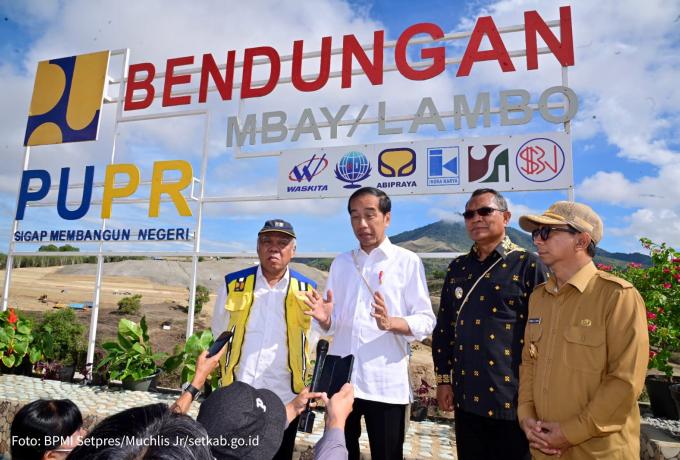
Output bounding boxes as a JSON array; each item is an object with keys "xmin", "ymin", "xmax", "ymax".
[{"xmin": 24, "ymin": 51, "xmax": 109, "ymax": 145}]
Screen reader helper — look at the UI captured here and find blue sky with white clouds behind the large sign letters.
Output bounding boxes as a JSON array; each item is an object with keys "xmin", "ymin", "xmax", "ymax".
[{"xmin": 0, "ymin": 0, "xmax": 680, "ymax": 253}]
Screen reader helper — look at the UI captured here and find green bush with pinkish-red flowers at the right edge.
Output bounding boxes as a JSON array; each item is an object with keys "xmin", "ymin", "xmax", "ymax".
[{"xmin": 614, "ymin": 238, "xmax": 680, "ymax": 378}]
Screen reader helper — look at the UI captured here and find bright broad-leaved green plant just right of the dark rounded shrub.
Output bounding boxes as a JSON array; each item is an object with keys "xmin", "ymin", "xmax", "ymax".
[{"xmin": 97, "ymin": 316, "xmax": 166, "ymax": 381}]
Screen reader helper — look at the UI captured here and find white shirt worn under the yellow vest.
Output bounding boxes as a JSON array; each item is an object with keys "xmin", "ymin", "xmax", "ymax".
[{"xmin": 212, "ymin": 266, "xmax": 296, "ymax": 404}]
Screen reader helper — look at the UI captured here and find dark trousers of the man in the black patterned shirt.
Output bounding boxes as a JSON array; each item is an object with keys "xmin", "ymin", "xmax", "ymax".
[{"xmin": 455, "ymin": 410, "xmax": 531, "ymax": 460}]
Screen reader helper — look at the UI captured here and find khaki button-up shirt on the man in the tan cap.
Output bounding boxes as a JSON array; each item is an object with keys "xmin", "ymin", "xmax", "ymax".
[{"xmin": 517, "ymin": 262, "xmax": 649, "ymax": 459}]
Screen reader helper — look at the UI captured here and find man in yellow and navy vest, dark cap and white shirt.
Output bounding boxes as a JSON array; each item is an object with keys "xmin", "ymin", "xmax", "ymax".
[{"xmin": 212, "ymin": 219, "xmax": 316, "ymax": 459}]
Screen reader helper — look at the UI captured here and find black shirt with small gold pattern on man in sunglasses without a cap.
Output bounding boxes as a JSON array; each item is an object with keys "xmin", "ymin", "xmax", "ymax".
[{"xmin": 432, "ymin": 236, "xmax": 547, "ymax": 420}]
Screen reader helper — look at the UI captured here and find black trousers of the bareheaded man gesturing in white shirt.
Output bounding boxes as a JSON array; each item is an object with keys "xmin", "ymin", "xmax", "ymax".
[{"xmin": 345, "ymin": 398, "xmax": 406, "ymax": 460}]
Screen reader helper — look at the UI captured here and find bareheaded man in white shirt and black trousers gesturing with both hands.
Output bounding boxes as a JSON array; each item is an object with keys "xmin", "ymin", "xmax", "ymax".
[{"xmin": 307, "ymin": 187, "xmax": 435, "ymax": 460}]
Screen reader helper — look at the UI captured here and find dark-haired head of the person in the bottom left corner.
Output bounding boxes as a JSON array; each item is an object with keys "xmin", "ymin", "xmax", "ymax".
[{"xmin": 10, "ymin": 399, "xmax": 83, "ymax": 460}]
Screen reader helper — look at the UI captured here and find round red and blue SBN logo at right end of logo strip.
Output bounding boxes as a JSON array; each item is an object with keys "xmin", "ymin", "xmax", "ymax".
[{"xmin": 515, "ymin": 137, "xmax": 566, "ymax": 182}]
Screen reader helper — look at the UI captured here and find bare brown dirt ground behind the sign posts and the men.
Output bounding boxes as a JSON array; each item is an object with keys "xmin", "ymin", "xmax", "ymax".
[{"xmin": 0, "ymin": 260, "xmax": 434, "ymax": 396}]
